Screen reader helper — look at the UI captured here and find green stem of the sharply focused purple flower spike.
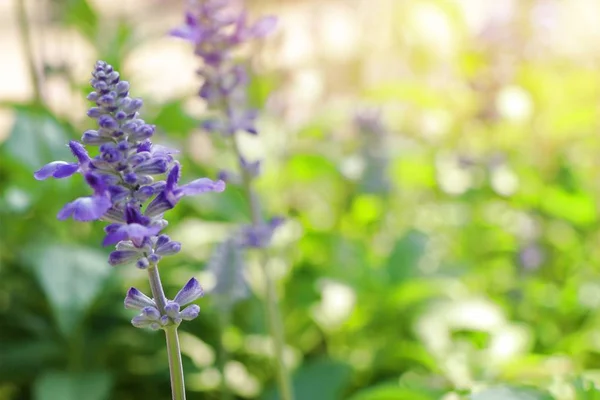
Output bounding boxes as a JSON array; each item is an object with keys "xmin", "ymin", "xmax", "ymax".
[{"xmin": 148, "ymin": 264, "xmax": 185, "ymax": 400}]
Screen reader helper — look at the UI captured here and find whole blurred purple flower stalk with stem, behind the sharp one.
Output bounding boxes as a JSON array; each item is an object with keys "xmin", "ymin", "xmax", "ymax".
[{"xmin": 171, "ymin": 0, "xmax": 293, "ymax": 400}]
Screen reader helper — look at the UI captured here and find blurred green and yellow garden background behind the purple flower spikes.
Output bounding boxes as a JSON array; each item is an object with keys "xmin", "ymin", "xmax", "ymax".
[{"xmin": 0, "ymin": 0, "xmax": 600, "ymax": 400}]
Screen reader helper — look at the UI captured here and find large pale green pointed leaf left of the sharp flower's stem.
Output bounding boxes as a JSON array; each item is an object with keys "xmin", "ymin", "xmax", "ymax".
[{"xmin": 25, "ymin": 246, "xmax": 111, "ymax": 336}]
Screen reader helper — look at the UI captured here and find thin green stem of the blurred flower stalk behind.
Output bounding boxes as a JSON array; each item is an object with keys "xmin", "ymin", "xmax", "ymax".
[{"xmin": 232, "ymin": 135, "xmax": 294, "ymax": 400}]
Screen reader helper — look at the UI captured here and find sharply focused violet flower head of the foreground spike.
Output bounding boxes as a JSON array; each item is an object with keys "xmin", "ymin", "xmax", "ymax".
[{"xmin": 34, "ymin": 61, "xmax": 225, "ymax": 325}]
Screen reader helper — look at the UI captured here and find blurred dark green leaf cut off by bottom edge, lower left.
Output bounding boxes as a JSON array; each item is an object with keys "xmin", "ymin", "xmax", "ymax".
[{"xmin": 34, "ymin": 372, "xmax": 112, "ymax": 400}]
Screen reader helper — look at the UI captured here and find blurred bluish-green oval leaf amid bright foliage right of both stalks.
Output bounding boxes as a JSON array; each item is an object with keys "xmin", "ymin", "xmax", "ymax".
[{"xmin": 386, "ymin": 231, "xmax": 428, "ymax": 283}]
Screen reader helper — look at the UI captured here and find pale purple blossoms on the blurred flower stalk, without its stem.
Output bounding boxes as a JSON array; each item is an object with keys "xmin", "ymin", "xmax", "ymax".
[{"xmin": 170, "ymin": 0, "xmax": 282, "ymax": 247}]
